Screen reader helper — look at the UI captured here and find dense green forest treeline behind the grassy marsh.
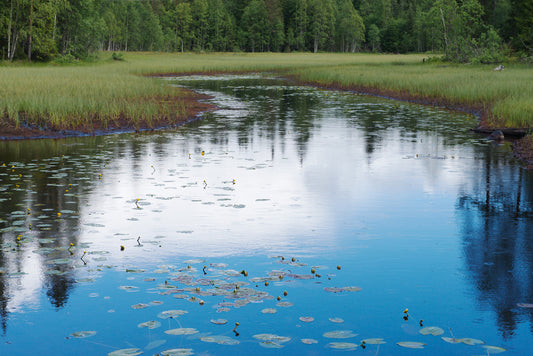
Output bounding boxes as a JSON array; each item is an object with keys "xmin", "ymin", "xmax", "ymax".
[{"xmin": 0, "ymin": 0, "xmax": 533, "ymax": 62}]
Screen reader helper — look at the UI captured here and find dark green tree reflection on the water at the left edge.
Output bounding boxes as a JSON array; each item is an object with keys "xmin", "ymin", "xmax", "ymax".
[{"xmin": 0, "ymin": 137, "xmax": 109, "ymax": 332}]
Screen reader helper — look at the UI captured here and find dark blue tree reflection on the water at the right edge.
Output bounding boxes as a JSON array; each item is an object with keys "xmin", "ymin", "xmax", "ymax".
[{"xmin": 457, "ymin": 147, "xmax": 533, "ymax": 337}]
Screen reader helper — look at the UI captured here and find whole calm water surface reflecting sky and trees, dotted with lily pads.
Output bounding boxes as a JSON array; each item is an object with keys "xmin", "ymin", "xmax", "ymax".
[{"xmin": 0, "ymin": 76, "xmax": 533, "ymax": 355}]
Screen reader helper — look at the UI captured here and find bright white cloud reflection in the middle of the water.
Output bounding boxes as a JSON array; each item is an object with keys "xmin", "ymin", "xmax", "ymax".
[{"xmin": 81, "ymin": 138, "xmax": 327, "ymax": 256}]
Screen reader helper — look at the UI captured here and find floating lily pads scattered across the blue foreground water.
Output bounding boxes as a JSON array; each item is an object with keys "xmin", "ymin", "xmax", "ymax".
[{"xmin": 64, "ymin": 252, "xmax": 505, "ymax": 356}]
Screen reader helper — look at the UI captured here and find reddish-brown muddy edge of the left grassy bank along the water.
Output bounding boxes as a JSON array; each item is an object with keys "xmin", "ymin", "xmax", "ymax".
[{"xmin": 0, "ymin": 89, "xmax": 215, "ymax": 140}]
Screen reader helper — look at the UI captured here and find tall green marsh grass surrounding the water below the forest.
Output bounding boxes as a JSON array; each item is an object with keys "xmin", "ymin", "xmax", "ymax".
[{"xmin": 0, "ymin": 53, "xmax": 533, "ymax": 138}]
